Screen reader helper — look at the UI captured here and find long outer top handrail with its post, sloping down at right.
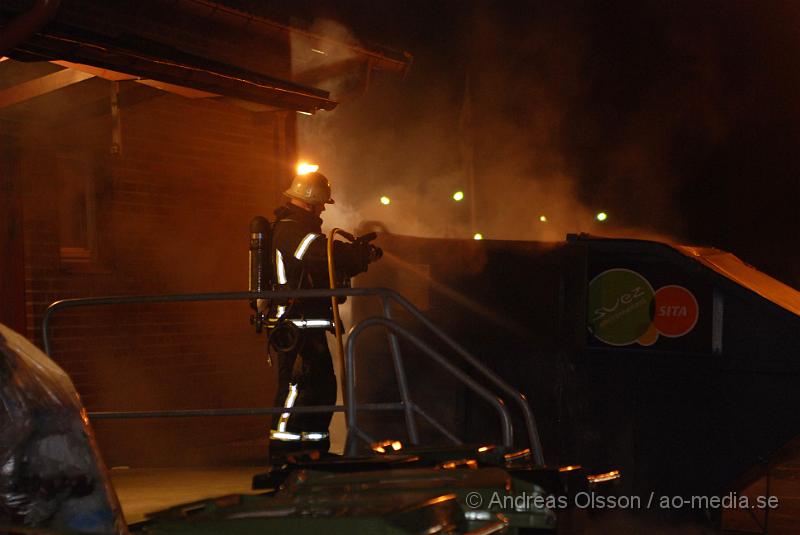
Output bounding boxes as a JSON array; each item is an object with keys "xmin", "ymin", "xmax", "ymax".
[{"xmin": 42, "ymin": 287, "xmax": 544, "ymax": 465}]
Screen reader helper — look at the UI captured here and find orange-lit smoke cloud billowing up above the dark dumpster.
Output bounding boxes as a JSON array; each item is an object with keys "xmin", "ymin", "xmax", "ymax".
[{"xmin": 293, "ymin": 9, "xmax": 688, "ymax": 246}]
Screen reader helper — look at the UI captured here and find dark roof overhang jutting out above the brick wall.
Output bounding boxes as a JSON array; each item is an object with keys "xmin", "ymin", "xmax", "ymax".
[{"xmin": 0, "ymin": 0, "xmax": 411, "ymax": 113}]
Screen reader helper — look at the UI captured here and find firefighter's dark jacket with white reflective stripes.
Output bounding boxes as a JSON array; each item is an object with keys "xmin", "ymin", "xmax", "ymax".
[{"xmin": 272, "ymin": 203, "xmax": 367, "ymax": 321}]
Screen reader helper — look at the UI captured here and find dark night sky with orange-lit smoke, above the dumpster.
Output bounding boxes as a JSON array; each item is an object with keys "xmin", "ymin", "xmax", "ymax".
[{"xmin": 239, "ymin": 0, "xmax": 800, "ymax": 287}]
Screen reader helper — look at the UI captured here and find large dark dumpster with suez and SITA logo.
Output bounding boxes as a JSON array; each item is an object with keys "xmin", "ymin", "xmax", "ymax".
[{"xmin": 352, "ymin": 234, "xmax": 800, "ymax": 495}]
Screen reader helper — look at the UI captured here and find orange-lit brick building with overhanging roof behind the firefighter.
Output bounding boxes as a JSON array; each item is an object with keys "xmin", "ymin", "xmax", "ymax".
[{"xmin": 0, "ymin": 0, "xmax": 408, "ymax": 465}]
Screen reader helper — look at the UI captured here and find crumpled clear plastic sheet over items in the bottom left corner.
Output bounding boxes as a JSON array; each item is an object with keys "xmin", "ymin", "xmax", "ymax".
[{"xmin": 0, "ymin": 325, "xmax": 127, "ymax": 534}]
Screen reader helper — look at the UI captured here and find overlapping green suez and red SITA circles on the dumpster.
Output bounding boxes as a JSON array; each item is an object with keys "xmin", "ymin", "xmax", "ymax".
[{"xmin": 588, "ymin": 268, "xmax": 700, "ymax": 346}]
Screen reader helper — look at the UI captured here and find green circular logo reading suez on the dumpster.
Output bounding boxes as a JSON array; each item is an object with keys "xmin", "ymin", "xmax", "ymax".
[{"xmin": 587, "ymin": 268, "xmax": 655, "ymax": 346}]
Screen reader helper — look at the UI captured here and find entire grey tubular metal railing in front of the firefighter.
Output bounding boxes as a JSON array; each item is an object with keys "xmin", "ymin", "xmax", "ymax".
[{"xmin": 42, "ymin": 288, "xmax": 544, "ymax": 465}]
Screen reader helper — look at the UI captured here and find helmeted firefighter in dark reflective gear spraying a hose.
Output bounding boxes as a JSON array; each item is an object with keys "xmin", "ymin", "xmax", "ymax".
[{"xmin": 268, "ymin": 172, "xmax": 379, "ymax": 460}]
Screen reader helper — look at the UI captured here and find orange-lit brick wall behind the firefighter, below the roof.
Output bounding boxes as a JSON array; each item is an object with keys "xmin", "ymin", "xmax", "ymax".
[{"xmin": 16, "ymin": 80, "xmax": 294, "ymax": 466}]
